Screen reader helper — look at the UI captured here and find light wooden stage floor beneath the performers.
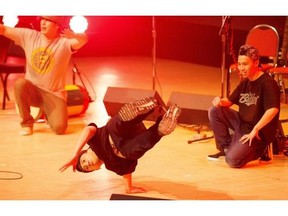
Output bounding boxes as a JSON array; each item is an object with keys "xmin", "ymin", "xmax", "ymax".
[{"xmin": 0, "ymin": 56, "xmax": 288, "ymax": 213}]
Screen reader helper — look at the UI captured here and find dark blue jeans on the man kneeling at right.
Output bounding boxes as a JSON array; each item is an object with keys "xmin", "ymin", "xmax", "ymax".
[{"xmin": 208, "ymin": 106, "xmax": 269, "ymax": 168}]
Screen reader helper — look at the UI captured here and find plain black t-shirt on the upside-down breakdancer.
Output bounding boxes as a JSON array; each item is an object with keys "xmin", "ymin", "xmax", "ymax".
[{"xmin": 87, "ymin": 123, "xmax": 138, "ymax": 176}]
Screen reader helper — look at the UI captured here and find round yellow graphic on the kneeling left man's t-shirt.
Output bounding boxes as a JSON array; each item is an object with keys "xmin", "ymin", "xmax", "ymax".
[{"xmin": 31, "ymin": 47, "xmax": 55, "ymax": 74}]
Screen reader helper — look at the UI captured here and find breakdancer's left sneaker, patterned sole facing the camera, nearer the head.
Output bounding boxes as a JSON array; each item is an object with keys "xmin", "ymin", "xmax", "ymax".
[{"xmin": 118, "ymin": 97, "xmax": 158, "ymax": 121}]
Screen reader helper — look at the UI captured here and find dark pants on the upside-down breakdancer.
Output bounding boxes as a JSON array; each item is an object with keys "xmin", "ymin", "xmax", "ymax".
[{"xmin": 107, "ymin": 110, "xmax": 162, "ymax": 160}]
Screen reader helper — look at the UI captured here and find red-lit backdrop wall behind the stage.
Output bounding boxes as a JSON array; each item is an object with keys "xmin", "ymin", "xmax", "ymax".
[{"xmin": 1, "ymin": 16, "xmax": 285, "ymax": 67}]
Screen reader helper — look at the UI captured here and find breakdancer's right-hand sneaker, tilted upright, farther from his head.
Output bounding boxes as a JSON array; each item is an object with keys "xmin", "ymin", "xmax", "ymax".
[{"xmin": 158, "ymin": 104, "xmax": 181, "ymax": 136}]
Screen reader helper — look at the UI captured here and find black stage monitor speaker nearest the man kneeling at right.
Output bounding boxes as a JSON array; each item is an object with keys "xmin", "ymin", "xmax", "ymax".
[{"xmin": 167, "ymin": 92, "xmax": 215, "ymax": 125}]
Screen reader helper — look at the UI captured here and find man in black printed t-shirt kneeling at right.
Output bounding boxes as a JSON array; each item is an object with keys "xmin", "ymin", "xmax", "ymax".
[{"xmin": 208, "ymin": 45, "xmax": 280, "ymax": 165}]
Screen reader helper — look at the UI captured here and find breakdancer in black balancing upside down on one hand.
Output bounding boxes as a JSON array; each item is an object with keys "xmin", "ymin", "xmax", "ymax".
[{"xmin": 60, "ymin": 97, "xmax": 181, "ymax": 193}]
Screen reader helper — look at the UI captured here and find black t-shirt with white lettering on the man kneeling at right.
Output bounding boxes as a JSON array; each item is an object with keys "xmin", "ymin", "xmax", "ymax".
[{"xmin": 228, "ymin": 73, "xmax": 280, "ymax": 143}]
